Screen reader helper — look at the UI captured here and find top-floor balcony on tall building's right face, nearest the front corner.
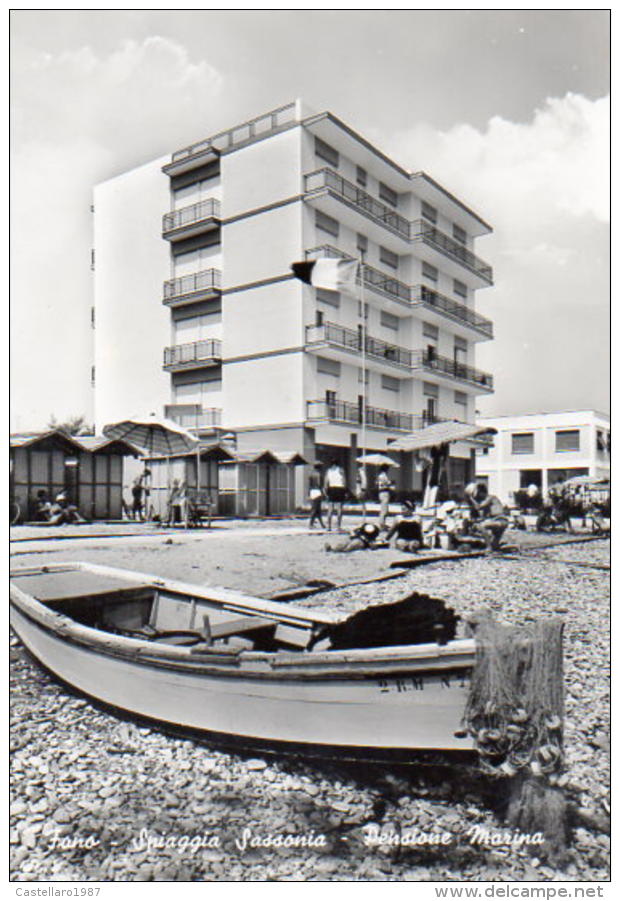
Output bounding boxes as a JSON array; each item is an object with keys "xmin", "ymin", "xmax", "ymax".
[{"xmin": 304, "ymin": 167, "xmax": 409, "ymax": 253}]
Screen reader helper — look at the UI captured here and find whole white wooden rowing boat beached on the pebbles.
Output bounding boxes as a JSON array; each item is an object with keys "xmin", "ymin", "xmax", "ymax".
[{"xmin": 10, "ymin": 563, "xmax": 475, "ymax": 760}]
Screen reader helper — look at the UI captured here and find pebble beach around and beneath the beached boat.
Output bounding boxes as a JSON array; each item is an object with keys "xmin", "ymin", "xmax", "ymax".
[{"xmin": 9, "ymin": 533, "xmax": 610, "ymax": 881}]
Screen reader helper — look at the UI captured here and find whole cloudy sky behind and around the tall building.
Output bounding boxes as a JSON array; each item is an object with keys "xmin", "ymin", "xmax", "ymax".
[{"xmin": 10, "ymin": 10, "xmax": 610, "ymax": 430}]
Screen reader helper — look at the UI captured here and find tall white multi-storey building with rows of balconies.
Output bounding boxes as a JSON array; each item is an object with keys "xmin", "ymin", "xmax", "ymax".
[{"xmin": 94, "ymin": 101, "xmax": 493, "ymax": 510}]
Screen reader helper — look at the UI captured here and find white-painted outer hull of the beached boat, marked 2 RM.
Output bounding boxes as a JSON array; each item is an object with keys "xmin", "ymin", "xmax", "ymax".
[{"xmin": 11, "ymin": 567, "xmax": 474, "ymax": 757}]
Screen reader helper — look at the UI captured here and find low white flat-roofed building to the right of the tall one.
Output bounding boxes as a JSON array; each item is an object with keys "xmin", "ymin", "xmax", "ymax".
[{"xmin": 476, "ymin": 410, "xmax": 611, "ymax": 503}]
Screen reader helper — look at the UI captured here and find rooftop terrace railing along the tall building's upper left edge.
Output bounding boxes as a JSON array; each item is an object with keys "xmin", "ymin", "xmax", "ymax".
[{"xmin": 162, "ymin": 103, "xmax": 297, "ymax": 176}]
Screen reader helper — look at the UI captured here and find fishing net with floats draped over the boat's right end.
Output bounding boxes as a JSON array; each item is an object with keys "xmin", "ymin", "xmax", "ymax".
[{"xmin": 465, "ymin": 619, "xmax": 564, "ymax": 783}]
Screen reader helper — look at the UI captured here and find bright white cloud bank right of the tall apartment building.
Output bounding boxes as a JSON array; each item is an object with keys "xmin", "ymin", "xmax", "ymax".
[{"xmin": 384, "ymin": 94, "xmax": 610, "ymax": 414}]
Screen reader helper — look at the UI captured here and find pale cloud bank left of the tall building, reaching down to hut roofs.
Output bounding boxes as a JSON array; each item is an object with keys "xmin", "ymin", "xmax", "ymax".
[{"xmin": 11, "ymin": 36, "xmax": 223, "ymax": 428}]
